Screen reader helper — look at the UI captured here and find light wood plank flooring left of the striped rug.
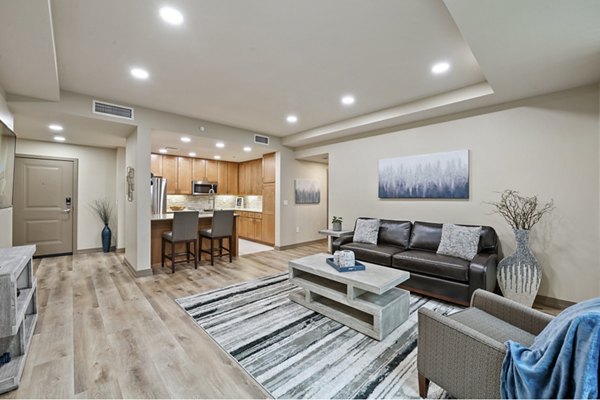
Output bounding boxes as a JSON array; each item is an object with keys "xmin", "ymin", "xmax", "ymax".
[{"xmin": 0, "ymin": 241, "xmax": 327, "ymax": 398}]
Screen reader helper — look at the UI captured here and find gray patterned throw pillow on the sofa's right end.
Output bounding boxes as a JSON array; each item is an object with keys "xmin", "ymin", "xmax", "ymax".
[{"xmin": 437, "ymin": 224, "xmax": 481, "ymax": 261}]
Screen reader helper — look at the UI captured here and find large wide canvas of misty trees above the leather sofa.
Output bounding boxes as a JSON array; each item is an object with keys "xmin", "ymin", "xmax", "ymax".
[{"xmin": 379, "ymin": 150, "xmax": 469, "ymax": 199}]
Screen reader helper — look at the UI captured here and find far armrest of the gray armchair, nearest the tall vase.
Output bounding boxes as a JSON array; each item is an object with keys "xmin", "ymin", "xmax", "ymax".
[{"xmin": 471, "ymin": 290, "xmax": 554, "ymax": 336}]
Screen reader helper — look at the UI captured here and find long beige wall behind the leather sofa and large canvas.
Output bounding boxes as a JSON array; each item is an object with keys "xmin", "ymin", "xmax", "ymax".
[{"xmin": 297, "ymin": 85, "xmax": 600, "ymax": 301}]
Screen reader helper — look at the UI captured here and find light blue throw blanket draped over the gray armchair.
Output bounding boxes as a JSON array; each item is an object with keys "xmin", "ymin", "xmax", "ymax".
[{"xmin": 500, "ymin": 297, "xmax": 600, "ymax": 399}]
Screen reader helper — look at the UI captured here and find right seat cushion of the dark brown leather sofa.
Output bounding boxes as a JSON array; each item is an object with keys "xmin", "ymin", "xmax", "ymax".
[{"xmin": 392, "ymin": 250, "xmax": 470, "ymax": 282}]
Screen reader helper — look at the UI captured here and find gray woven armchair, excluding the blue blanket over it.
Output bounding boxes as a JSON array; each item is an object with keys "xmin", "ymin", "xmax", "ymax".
[{"xmin": 417, "ymin": 289, "xmax": 553, "ymax": 399}]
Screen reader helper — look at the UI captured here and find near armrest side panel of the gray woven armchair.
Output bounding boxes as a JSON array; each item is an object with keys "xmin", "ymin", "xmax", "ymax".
[{"xmin": 417, "ymin": 308, "xmax": 506, "ymax": 399}]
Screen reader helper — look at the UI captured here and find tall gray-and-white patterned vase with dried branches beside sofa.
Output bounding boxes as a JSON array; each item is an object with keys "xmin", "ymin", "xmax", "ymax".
[{"xmin": 488, "ymin": 190, "xmax": 554, "ymax": 307}]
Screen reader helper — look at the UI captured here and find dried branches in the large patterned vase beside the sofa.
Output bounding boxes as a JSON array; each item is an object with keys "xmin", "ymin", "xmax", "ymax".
[{"xmin": 487, "ymin": 189, "xmax": 554, "ymax": 230}]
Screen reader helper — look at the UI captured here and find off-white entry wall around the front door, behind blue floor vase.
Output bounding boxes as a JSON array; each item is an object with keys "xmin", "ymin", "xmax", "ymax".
[{"xmin": 17, "ymin": 139, "xmax": 119, "ymax": 250}]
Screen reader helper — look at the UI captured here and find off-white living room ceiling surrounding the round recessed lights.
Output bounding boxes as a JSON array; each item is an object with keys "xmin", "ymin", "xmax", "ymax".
[{"xmin": 0, "ymin": 0, "xmax": 600, "ymax": 152}]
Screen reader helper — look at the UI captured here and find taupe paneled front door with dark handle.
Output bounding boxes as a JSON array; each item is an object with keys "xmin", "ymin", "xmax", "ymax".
[{"xmin": 13, "ymin": 156, "xmax": 75, "ymax": 256}]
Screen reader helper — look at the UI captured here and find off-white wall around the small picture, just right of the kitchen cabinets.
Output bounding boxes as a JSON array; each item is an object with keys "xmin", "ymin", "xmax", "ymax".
[{"xmin": 276, "ymin": 149, "xmax": 328, "ymax": 247}]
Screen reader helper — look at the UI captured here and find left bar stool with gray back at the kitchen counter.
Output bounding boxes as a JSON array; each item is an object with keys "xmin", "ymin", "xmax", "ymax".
[{"xmin": 161, "ymin": 211, "xmax": 198, "ymax": 273}]
